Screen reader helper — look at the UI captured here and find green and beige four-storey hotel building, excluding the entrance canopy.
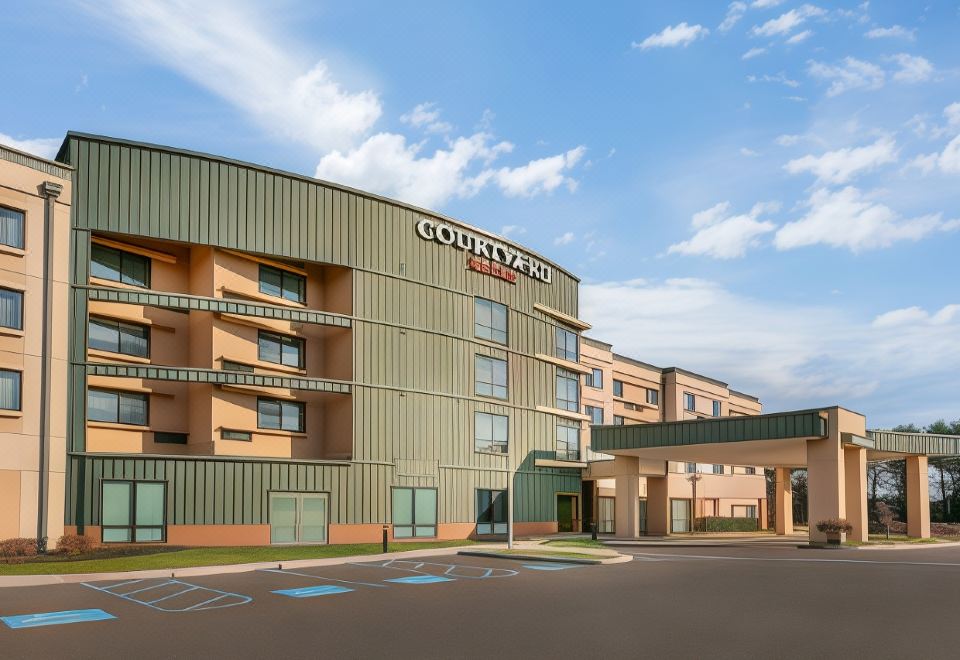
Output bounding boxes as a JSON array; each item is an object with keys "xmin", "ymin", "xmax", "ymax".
[{"xmin": 0, "ymin": 133, "xmax": 765, "ymax": 545}]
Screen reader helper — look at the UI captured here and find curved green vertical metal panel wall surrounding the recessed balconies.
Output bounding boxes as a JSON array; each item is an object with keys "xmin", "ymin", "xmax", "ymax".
[{"xmin": 65, "ymin": 134, "xmax": 580, "ymax": 524}]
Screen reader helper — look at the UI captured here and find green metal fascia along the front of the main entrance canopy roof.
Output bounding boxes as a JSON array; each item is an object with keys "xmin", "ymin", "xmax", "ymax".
[{"xmin": 590, "ymin": 410, "xmax": 827, "ymax": 452}]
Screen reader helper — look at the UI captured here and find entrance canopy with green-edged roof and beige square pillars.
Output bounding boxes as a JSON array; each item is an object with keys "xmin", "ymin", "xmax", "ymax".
[{"xmin": 591, "ymin": 406, "xmax": 960, "ymax": 542}]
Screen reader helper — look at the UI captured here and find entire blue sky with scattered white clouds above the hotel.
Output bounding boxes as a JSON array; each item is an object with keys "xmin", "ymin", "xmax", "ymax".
[{"xmin": 0, "ymin": 0, "xmax": 960, "ymax": 426}]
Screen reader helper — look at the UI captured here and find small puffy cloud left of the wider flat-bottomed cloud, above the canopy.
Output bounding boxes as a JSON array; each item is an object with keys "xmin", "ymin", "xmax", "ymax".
[{"xmin": 667, "ymin": 202, "xmax": 780, "ymax": 259}]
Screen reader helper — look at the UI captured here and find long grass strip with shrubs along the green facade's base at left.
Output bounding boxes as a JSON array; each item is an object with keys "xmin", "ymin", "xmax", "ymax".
[{"xmin": 0, "ymin": 540, "xmax": 474, "ymax": 575}]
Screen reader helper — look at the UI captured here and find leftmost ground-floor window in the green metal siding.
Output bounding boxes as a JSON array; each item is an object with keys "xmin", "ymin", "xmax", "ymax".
[{"xmin": 100, "ymin": 481, "xmax": 167, "ymax": 543}]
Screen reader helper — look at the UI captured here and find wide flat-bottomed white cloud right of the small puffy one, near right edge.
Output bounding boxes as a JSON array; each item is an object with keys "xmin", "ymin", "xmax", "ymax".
[{"xmin": 774, "ymin": 186, "xmax": 953, "ymax": 252}]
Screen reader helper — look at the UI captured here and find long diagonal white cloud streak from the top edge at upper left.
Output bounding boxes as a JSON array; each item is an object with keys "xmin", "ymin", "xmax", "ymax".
[{"xmin": 88, "ymin": 0, "xmax": 382, "ymax": 150}]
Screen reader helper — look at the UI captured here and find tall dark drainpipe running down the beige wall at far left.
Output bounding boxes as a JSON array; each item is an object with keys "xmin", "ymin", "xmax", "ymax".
[{"xmin": 37, "ymin": 181, "xmax": 63, "ymax": 551}]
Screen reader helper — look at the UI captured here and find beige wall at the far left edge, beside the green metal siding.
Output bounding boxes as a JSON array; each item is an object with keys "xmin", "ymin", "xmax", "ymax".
[{"xmin": 0, "ymin": 146, "xmax": 71, "ymax": 547}]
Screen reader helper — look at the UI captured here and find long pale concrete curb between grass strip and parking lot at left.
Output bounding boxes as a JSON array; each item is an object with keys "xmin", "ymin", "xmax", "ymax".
[{"xmin": 0, "ymin": 545, "xmax": 480, "ymax": 589}]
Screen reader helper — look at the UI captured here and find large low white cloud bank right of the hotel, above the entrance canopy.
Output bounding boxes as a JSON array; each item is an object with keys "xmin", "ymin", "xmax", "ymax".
[{"xmin": 580, "ymin": 279, "xmax": 960, "ymax": 424}]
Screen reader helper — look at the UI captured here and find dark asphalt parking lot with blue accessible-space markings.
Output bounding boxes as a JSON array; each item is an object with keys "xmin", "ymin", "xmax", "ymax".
[{"xmin": 0, "ymin": 547, "xmax": 960, "ymax": 658}]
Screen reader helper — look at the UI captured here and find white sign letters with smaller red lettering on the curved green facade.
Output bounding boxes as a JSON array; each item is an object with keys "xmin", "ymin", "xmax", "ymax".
[{"xmin": 417, "ymin": 218, "xmax": 553, "ymax": 284}]
